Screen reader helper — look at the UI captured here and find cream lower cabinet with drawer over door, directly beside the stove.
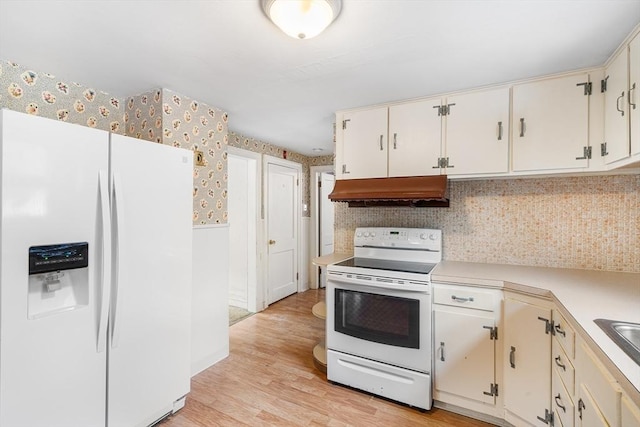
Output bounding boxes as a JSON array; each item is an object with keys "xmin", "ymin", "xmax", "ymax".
[{"xmin": 433, "ymin": 284, "xmax": 502, "ymax": 416}]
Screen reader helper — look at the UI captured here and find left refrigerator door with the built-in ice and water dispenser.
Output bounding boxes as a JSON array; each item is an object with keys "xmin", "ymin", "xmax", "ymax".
[{"xmin": 0, "ymin": 110, "xmax": 109, "ymax": 427}]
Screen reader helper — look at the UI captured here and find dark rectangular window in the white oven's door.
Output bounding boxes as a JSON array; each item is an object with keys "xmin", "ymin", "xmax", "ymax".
[{"xmin": 335, "ymin": 289, "xmax": 420, "ymax": 348}]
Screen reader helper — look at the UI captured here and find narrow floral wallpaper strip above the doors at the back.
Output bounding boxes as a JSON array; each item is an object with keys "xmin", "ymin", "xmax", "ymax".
[{"xmin": 229, "ymin": 131, "xmax": 333, "ymax": 217}]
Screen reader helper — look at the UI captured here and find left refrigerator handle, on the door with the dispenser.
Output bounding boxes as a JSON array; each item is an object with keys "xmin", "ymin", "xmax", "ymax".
[{"xmin": 95, "ymin": 171, "xmax": 111, "ymax": 353}]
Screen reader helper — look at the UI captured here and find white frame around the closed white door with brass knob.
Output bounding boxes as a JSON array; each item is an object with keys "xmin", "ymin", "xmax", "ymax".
[{"xmin": 261, "ymin": 154, "xmax": 304, "ymax": 308}]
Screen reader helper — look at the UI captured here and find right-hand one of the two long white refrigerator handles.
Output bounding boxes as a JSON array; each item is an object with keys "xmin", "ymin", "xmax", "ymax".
[{"xmin": 111, "ymin": 174, "xmax": 124, "ymax": 348}]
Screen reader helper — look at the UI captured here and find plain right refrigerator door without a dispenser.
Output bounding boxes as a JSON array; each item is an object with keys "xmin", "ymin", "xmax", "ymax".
[{"xmin": 107, "ymin": 135, "xmax": 193, "ymax": 427}]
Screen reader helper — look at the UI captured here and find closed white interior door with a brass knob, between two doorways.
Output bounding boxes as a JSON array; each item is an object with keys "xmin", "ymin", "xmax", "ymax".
[{"xmin": 265, "ymin": 157, "xmax": 301, "ymax": 304}]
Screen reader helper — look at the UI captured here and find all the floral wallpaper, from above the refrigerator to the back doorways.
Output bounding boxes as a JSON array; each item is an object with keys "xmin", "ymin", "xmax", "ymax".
[{"xmin": 0, "ymin": 61, "xmax": 333, "ymax": 225}]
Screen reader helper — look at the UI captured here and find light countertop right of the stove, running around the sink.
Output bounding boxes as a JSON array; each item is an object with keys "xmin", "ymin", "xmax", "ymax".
[{"xmin": 431, "ymin": 261, "xmax": 640, "ymax": 404}]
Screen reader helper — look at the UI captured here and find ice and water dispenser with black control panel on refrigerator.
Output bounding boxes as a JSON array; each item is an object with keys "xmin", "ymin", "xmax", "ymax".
[{"xmin": 28, "ymin": 242, "xmax": 89, "ymax": 319}]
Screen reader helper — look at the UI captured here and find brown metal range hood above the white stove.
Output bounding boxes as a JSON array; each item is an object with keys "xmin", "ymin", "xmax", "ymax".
[{"xmin": 329, "ymin": 175, "xmax": 449, "ymax": 208}]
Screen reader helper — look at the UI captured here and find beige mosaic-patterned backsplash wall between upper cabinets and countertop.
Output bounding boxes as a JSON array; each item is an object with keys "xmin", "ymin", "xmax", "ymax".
[{"xmin": 335, "ymin": 175, "xmax": 640, "ymax": 273}]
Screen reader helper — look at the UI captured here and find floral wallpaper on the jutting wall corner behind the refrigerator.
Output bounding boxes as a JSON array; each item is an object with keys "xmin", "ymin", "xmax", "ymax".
[{"xmin": 124, "ymin": 89, "xmax": 229, "ymax": 225}]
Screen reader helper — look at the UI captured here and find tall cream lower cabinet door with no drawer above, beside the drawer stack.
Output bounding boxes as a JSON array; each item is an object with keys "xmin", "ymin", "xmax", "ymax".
[{"xmin": 504, "ymin": 298, "xmax": 551, "ymax": 426}]
